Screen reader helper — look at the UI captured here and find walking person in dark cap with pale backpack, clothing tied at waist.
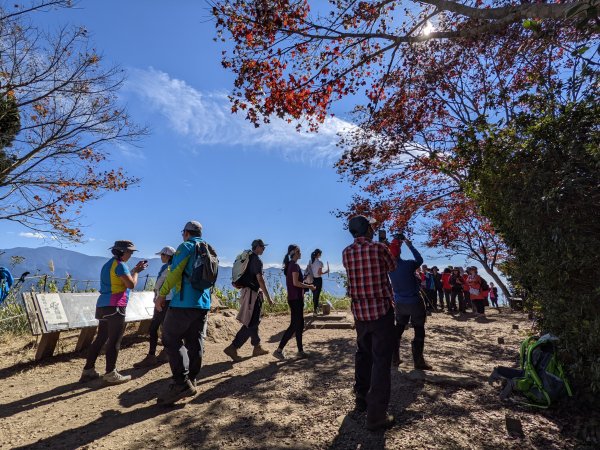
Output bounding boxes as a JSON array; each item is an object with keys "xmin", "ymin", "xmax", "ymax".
[{"xmin": 223, "ymin": 239, "xmax": 275, "ymax": 362}]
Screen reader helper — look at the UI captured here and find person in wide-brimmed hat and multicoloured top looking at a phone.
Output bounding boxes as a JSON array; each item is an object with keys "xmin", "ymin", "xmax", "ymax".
[{"xmin": 79, "ymin": 241, "xmax": 148, "ymax": 384}]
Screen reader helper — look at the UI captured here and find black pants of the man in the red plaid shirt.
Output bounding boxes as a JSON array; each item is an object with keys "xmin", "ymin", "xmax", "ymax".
[{"xmin": 354, "ymin": 308, "xmax": 394, "ymax": 423}]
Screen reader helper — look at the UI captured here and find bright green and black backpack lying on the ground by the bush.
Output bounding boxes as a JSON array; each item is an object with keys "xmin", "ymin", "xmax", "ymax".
[{"xmin": 488, "ymin": 334, "xmax": 573, "ymax": 408}]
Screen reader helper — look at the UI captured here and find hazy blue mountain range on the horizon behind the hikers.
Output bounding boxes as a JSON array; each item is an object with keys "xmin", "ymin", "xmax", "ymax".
[{"xmin": 0, "ymin": 246, "xmax": 345, "ymax": 296}]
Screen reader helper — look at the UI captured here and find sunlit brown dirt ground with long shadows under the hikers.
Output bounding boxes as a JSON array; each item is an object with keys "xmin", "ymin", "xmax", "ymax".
[{"xmin": 0, "ymin": 310, "xmax": 592, "ymax": 449}]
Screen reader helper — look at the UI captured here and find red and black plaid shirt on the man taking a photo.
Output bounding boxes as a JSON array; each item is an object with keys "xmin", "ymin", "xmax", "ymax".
[{"xmin": 342, "ymin": 237, "xmax": 396, "ymax": 321}]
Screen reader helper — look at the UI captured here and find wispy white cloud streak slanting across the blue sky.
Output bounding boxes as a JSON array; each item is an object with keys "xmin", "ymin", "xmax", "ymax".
[{"xmin": 127, "ymin": 68, "xmax": 355, "ymax": 163}]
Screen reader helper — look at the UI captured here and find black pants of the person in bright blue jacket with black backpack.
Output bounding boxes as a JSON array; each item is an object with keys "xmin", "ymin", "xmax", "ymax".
[{"xmin": 163, "ymin": 307, "xmax": 208, "ymax": 384}]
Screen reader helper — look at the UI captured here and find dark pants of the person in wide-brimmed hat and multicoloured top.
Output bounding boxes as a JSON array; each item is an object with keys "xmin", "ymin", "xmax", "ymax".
[{"xmin": 84, "ymin": 306, "xmax": 125, "ymax": 373}]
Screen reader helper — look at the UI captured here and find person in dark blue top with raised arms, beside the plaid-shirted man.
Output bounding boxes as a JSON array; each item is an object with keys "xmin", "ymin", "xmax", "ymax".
[{"xmin": 390, "ymin": 234, "xmax": 431, "ymax": 370}]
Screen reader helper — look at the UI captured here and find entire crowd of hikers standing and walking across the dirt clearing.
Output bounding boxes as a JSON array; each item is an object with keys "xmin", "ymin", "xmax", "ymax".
[{"xmin": 80, "ymin": 220, "xmax": 498, "ymax": 430}]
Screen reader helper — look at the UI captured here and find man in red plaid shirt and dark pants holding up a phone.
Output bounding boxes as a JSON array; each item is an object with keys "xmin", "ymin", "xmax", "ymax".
[{"xmin": 342, "ymin": 216, "xmax": 396, "ymax": 430}]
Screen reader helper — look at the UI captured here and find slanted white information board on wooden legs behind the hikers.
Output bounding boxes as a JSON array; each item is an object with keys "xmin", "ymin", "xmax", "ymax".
[{"xmin": 23, "ymin": 291, "xmax": 154, "ymax": 361}]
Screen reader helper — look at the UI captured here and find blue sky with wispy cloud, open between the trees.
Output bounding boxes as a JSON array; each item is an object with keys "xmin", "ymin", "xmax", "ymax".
[{"xmin": 0, "ymin": 0, "xmax": 486, "ymax": 274}]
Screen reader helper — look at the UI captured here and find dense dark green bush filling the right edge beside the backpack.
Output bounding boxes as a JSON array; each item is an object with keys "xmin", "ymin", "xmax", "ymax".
[{"xmin": 462, "ymin": 96, "xmax": 600, "ymax": 399}]
